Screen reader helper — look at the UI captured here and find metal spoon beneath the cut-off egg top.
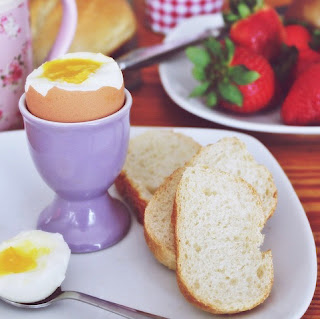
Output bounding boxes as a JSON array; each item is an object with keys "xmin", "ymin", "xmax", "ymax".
[{"xmin": 0, "ymin": 287, "xmax": 168, "ymax": 319}]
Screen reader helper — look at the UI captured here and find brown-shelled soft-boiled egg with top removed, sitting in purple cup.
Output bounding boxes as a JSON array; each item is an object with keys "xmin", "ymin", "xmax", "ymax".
[{"xmin": 25, "ymin": 52, "xmax": 125, "ymax": 123}]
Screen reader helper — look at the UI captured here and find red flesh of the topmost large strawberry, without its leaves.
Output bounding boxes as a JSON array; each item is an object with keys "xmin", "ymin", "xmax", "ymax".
[{"xmin": 226, "ymin": 0, "xmax": 285, "ymax": 60}]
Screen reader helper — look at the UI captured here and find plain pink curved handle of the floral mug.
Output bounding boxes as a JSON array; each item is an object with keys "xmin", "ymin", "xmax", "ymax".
[{"xmin": 46, "ymin": 0, "xmax": 78, "ymax": 61}]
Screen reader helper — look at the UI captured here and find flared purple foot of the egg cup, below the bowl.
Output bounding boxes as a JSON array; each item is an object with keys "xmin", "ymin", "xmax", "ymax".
[{"xmin": 37, "ymin": 193, "xmax": 131, "ymax": 253}]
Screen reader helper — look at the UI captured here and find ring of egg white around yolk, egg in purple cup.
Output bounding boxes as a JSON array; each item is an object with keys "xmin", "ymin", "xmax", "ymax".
[{"xmin": 25, "ymin": 52, "xmax": 123, "ymax": 96}]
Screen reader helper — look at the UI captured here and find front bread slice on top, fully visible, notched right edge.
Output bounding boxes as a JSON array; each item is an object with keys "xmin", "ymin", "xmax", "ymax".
[{"xmin": 173, "ymin": 166, "xmax": 273, "ymax": 314}]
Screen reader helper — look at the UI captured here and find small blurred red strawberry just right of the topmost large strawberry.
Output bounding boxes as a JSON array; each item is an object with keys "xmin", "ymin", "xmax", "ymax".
[{"xmin": 284, "ymin": 24, "xmax": 311, "ymax": 51}]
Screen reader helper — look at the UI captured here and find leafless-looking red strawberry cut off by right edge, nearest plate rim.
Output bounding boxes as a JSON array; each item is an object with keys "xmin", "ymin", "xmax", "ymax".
[{"xmin": 281, "ymin": 63, "xmax": 320, "ymax": 125}]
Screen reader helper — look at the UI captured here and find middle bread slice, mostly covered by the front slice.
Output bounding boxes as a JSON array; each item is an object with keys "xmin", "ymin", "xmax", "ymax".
[{"xmin": 144, "ymin": 137, "xmax": 277, "ymax": 269}]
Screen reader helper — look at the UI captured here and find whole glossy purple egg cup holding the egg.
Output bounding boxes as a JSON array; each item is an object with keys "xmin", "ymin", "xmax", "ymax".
[{"xmin": 19, "ymin": 90, "xmax": 132, "ymax": 253}]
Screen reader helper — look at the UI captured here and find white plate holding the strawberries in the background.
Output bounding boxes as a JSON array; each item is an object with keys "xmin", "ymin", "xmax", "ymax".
[{"xmin": 159, "ymin": 14, "xmax": 320, "ymax": 135}]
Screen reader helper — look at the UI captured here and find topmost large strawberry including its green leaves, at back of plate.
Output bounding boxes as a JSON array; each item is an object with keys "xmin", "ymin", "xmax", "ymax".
[{"xmin": 224, "ymin": 0, "xmax": 285, "ymax": 60}]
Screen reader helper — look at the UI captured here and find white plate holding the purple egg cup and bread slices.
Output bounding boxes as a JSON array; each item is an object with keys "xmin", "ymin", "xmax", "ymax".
[{"xmin": 0, "ymin": 127, "xmax": 317, "ymax": 319}]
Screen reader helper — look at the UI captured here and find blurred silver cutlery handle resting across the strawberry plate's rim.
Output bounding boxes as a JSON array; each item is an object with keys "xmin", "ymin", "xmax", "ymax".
[{"xmin": 117, "ymin": 28, "xmax": 224, "ymax": 71}]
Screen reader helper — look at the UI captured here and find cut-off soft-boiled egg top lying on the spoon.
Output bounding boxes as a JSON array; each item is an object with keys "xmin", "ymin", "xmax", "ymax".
[{"xmin": 0, "ymin": 230, "xmax": 70, "ymax": 303}]
